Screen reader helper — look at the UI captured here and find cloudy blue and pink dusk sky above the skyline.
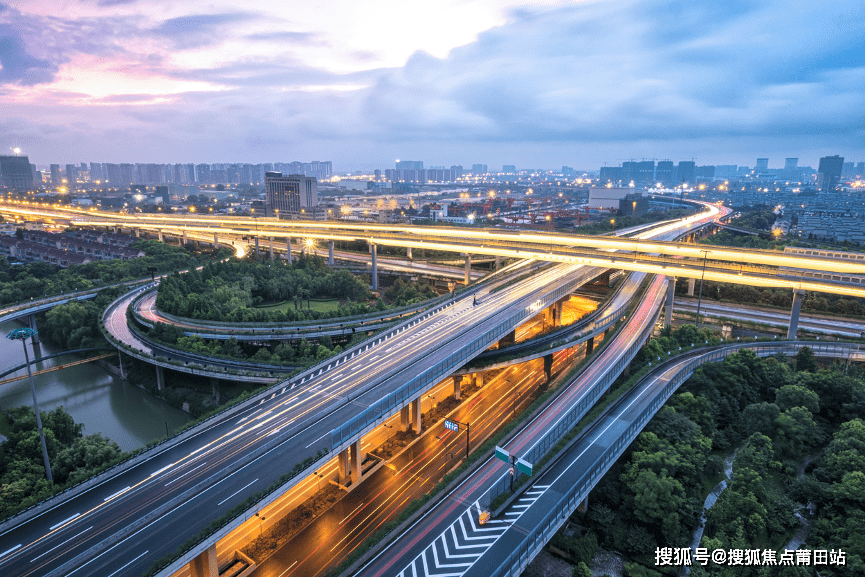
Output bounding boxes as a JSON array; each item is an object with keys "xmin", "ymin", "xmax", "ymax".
[{"xmin": 0, "ymin": 0, "xmax": 866, "ymax": 171}]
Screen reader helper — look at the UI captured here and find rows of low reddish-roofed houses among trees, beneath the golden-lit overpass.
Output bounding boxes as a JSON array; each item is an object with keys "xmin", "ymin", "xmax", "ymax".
[{"xmin": 0, "ymin": 230, "xmax": 145, "ymax": 268}]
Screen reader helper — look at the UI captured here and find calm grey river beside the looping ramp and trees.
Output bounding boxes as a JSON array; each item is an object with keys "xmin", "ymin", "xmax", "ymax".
[{"xmin": 0, "ymin": 321, "xmax": 190, "ymax": 451}]
